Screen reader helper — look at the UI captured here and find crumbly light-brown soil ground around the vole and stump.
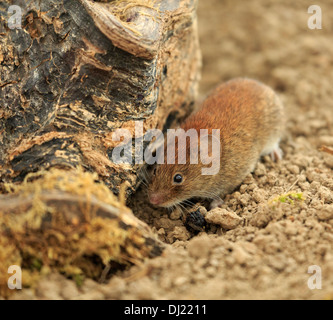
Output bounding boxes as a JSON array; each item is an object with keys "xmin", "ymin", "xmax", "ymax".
[{"xmin": 12, "ymin": 0, "xmax": 333, "ymax": 299}]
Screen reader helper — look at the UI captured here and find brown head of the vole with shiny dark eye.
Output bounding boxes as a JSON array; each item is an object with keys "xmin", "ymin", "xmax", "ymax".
[{"xmin": 148, "ymin": 130, "xmax": 220, "ymax": 207}]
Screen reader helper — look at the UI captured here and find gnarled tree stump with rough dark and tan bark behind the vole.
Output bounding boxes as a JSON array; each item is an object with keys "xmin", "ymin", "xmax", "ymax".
[{"xmin": 0, "ymin": 0, "xmax": 200, "ymax": 193}]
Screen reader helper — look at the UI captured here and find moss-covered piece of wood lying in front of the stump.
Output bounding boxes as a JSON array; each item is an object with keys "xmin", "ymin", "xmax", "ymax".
[{"xmin": 0, "ymin": 169, "xmax": 164, "ymax": 297}]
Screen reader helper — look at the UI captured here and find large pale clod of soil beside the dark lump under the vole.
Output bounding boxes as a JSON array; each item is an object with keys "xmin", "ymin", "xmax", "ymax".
[{"xmin": 205, "ymin": 208, "xmax": 243, "ymax": 230}]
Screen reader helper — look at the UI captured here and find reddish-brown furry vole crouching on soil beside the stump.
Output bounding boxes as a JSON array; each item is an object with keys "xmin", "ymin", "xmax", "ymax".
[{"xmin": 148, "ymin": 79, "xmax": 284, "ymax": 207}]
